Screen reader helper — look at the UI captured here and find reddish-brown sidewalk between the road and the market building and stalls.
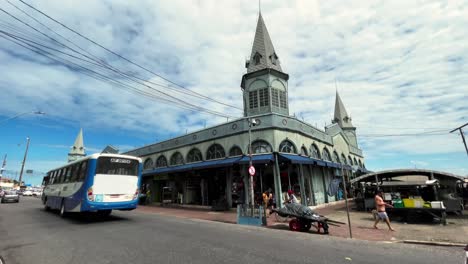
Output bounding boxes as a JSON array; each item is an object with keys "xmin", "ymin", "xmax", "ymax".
[{"xmin": 137, "ymin": 202, "xmax": 468, "ymax": 244}]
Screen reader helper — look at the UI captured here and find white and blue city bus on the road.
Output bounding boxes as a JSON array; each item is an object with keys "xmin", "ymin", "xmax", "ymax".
[{"xmin": 42, "ymin": 154, "xmax": 142, "ymax": 216}]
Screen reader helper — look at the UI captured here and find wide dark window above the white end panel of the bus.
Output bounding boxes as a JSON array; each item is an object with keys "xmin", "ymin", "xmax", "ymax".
[{"xmin": 96, "ymin": 157, "xmax": 138, "ymax": 176}]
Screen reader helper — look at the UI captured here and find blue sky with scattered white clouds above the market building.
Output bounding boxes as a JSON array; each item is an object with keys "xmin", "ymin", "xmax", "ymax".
[{"xmin": 0, "ymin": 0, "xmax": 468, "ymax": 184}]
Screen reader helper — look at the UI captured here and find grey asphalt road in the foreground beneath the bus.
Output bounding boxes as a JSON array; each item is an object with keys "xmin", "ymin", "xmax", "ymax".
[{"xmin": 0, "ymin": 197, "xmax": 464, "ymax": 264}]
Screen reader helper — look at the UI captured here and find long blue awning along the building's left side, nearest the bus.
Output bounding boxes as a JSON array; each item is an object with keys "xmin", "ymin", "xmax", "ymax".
[{"xmin": 143, "ymin": 157, "xmax": 241, "ymax": 176}]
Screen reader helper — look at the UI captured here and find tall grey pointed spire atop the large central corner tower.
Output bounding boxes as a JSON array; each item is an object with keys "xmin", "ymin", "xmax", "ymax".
[{"xmin": 246, "ymin": 10, "xmax": 283, "ymax": 73}]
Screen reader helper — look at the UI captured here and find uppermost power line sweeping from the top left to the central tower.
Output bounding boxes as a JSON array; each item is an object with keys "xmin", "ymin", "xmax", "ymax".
[{"xmin": 12, "ymin": 0, "xmax": 243, "ymax": 111}]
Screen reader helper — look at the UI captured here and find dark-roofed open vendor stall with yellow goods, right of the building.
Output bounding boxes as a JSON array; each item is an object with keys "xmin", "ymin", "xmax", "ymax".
[{"xmin": 351, "ymin": 170, "xmax": 463, "ymax": 224}]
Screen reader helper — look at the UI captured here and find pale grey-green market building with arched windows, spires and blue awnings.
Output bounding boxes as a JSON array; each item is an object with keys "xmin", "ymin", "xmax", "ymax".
[{"xmin": 125, "ymin": 14, "xmax": 365, "ymax": 207}]
